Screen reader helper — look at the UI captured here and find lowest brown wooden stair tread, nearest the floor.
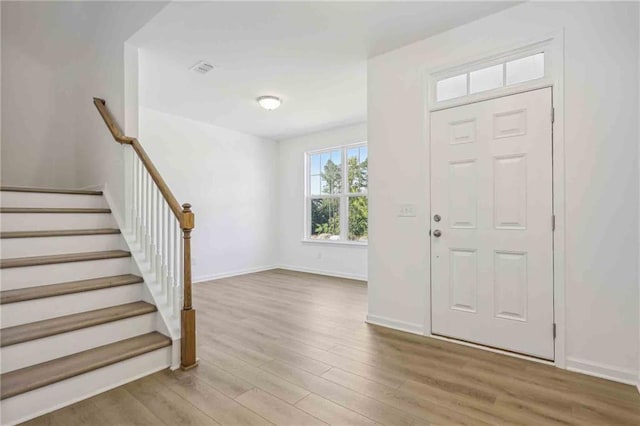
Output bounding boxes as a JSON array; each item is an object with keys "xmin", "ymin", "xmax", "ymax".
[{"xmin": 0, "ymin": 332, "xmax": 171, "ymax": 399}]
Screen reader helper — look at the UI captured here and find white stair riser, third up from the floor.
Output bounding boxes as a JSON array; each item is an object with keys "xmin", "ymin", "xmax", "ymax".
[{"xmin": 0, "ymin": 283, "xmax": 143, "ymax": 328}]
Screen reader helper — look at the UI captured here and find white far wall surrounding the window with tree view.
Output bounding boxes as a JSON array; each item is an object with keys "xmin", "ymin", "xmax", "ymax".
[{"xmin": 278, "ymin": 124, "xmax": 367, "ymax": 280}]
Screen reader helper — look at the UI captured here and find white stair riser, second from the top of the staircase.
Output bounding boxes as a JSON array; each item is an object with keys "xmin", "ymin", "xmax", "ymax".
[{"xmin": 1, "ymin": 213, "xmax": 117, "ymax": 232}]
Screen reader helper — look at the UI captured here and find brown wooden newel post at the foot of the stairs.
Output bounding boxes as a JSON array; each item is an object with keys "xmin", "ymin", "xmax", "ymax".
[{"xmin": 180, "ymin": 203, "xmax": 198, "ymax": 370}]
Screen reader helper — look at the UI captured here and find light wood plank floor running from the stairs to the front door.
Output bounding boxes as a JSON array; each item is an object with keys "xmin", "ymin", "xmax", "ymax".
[{"xmin": 23, "ymin": 270, "xmax": 640, "ymax": 426}]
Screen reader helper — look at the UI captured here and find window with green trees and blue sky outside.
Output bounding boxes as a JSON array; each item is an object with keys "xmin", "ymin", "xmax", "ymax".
[{"xmin": 306, "ymin": 144, "xmax": 369, "ymax": 243}]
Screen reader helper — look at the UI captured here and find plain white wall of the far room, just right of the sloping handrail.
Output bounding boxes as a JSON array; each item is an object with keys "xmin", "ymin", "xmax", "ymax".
[{"xmin": 139, "ymin": 107, "xmax": 278, "ymax": 282}]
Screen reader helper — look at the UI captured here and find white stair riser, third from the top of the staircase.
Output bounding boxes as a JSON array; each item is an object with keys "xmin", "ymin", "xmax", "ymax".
[{"xmin": 0, "ymin": 234, "xmax": 127, "ymax": 259}]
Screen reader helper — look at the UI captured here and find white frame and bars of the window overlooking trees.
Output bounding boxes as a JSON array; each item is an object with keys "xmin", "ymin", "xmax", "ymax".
[{"xmin": 302, "ymin": 141, "xmax": 369, "ymax": 247}]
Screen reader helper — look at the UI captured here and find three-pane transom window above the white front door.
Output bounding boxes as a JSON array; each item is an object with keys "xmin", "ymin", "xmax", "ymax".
[{"xmin": 436, "ymin": 52, "xmax": 545, "ymax": 102}]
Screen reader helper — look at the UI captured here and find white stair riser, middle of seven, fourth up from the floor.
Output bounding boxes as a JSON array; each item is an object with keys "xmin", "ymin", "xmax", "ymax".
[{"xmin": 0, "ymin": 257, "xmax": 133, "ymax": 290}]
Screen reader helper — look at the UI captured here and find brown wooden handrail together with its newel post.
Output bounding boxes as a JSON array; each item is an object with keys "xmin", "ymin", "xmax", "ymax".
[{"xmin": 93, "ymin": 98, "xmax": 197, "ymax": 370}]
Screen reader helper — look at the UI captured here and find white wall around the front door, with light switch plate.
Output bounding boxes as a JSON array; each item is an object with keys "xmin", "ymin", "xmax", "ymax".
[{"xmin": 368, "ymin": 3, "xmax": 639, "ymax": 382}]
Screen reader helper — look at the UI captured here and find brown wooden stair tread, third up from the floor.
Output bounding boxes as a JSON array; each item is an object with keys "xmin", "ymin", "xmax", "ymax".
[{"xmin": 0, "ymin": 274, "xmax": 143, "ymax": 305}]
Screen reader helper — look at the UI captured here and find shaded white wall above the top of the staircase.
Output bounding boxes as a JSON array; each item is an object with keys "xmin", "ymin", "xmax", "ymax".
[{"xmin": 1, "ymin": 1, "xmax": 166, "ymax": 216}]
